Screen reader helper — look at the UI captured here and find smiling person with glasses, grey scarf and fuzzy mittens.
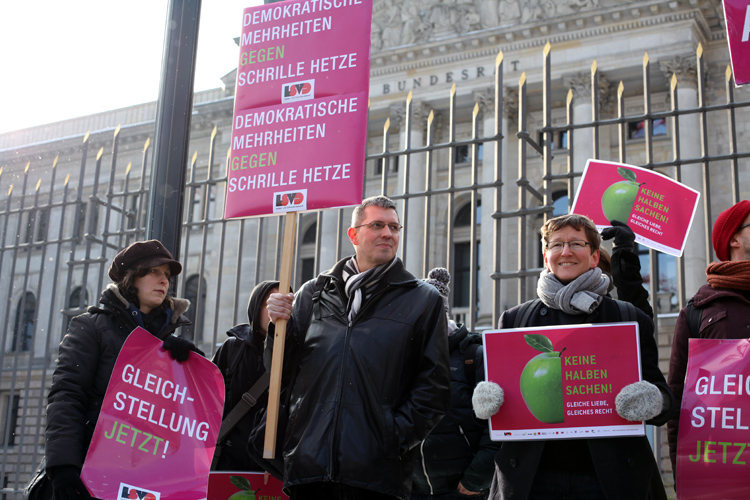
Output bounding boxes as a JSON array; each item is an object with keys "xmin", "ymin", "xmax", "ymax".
[{"xmin": 472, "ymin": 214, "xmax": 675, "ymax": 500}]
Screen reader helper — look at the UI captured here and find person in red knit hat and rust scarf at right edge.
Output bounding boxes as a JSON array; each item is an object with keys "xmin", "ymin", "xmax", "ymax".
[{"xmin": 667, "ymin": 200, "xmax": 750, "ymax": 480}]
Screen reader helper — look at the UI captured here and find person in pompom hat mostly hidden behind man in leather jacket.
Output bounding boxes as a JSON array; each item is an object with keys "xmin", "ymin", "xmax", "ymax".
[{"xmin": 411, "ymin": 267, "xmax": 500, "ymax": 500}]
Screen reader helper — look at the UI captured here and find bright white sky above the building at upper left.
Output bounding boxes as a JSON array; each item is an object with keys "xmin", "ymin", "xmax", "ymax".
[{"xmin": 0, "ymin": 0, "xmax": 263, "ymax": 133}]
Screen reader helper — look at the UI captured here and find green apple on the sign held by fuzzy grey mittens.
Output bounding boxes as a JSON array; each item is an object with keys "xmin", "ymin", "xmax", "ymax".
[{"xmin": 521, "ymin": 334, "xmax": 565, "ymax": 424}]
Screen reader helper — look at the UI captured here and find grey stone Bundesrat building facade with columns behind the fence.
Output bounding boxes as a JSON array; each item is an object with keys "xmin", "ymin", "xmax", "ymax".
[{"xmin": 0, "ymin": 0, "xmax": 750, "ymax": 498}]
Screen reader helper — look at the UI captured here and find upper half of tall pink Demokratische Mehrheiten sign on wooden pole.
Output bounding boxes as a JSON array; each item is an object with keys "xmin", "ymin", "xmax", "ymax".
[{"xmin": 234, "ymin": 0, "xmax": 372, "ymax": 112}]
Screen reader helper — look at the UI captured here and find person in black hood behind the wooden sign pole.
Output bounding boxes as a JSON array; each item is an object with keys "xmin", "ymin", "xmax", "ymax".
[{"xmin": 211, "ymin": 281, "xmax": 279, "ymax": 471}]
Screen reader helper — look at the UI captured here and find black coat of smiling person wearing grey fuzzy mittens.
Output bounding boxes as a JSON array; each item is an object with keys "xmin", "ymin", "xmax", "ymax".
[{"xmin": 492, "ymin": 297, "xmax": 676, "ymax": 500}]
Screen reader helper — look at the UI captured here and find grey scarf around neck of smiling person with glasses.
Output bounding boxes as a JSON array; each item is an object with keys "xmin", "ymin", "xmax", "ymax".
[{"xmin": 536, "ymin": 267, "xmax": 609, "ymax": 314}]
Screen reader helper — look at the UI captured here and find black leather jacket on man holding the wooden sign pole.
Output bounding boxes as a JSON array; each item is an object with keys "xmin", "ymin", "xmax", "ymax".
[{"xmin": 265, "ymin": 259, "xmax": 450, "ymax": 500}]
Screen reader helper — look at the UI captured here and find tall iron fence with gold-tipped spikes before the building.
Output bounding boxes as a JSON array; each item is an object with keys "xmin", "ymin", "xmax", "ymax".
[{"xmin": 0, "ymin": 45, "xmax": 750, "ymax": 498}]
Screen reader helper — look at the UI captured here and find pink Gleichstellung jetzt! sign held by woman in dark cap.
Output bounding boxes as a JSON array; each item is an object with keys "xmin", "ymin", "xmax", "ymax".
[{"xmin": 81, "ymin": 328, "xmax": 224, "ymax": 500}]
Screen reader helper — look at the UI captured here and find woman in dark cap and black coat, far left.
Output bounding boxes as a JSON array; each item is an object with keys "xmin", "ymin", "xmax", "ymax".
[{"xmin": 46, "ymin": 240, "xmax": 203, "ymax": 500}]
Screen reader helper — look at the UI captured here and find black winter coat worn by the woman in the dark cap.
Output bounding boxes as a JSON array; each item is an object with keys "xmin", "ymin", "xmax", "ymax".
[{"xmin": 46, "ymin": 284, "xmax": 190, "ymax": 468}]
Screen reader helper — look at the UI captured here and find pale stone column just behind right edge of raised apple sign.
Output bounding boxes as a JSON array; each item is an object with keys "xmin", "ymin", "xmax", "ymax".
[{"xmin": 659, "ymin": 56, "xmax": 708, "ymax": 298}]
